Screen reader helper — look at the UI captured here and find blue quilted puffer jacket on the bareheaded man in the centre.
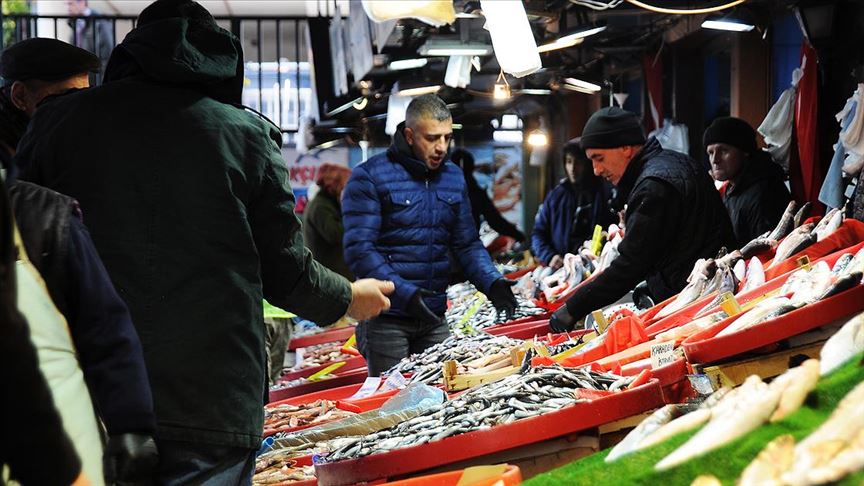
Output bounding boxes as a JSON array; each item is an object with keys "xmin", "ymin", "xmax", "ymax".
[{"xmin": 342, "ymin": 125, "xmax": 501, "ymax": 316}]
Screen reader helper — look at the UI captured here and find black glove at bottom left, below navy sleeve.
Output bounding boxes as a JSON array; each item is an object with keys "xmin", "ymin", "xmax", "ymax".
[{"xmin": 102, "ymin": 433, "xmax": 159, "ymax": 485}]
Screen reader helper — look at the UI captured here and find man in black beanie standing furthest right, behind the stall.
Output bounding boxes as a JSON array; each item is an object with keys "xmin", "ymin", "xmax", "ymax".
[{"xmin": 703, "ymin": 116, "xmax": 792, "ymax": 248}]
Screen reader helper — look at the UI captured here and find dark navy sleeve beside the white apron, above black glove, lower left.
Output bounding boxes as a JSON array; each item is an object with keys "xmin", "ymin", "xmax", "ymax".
[{"xmin": 66, "ymin": 218, "xmax": 156, "ymax": 435}]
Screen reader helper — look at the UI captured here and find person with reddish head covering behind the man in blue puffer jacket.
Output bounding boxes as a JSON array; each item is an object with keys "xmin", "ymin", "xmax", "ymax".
[{"xmin": 303, "ymin": 164, "xmax": 354, "ymax": 280}]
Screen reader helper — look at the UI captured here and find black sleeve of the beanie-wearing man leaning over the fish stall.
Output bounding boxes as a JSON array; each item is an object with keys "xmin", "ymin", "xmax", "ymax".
[{"xmin": 567, "ymin": 179, "xmax": 680, "ymax": 319}]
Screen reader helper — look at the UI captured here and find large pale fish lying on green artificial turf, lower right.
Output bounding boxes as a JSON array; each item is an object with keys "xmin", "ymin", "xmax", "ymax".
[{"xmin": 605, "ymin": 313, "xmax": 864, "ymax": 485}]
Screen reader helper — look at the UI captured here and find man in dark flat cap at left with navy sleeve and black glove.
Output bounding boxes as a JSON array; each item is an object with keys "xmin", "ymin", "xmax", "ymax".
[{"xmin": 0, "ymin": 38, "xmax": 158, "ymax": 484}]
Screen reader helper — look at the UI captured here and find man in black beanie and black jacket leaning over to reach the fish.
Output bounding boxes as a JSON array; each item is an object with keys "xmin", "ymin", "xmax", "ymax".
[{"xmin": 549, "ymin": 107, "xmax": 734, "ymax": 332}]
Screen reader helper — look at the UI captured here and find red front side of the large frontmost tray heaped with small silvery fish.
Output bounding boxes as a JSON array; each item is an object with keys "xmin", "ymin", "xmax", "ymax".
[{"xmin": 315, "ymin": 379, "xmax": 663, "ymax": 486}]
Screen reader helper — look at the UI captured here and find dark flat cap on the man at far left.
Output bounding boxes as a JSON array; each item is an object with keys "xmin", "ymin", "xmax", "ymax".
[{"xmin": 0, "ymin": 37, "xmax": 100, "ymax": 82}]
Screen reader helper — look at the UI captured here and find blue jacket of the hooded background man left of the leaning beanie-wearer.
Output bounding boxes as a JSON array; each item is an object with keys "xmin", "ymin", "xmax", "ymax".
[{"xmin": 531, "ymin": 179, "xmax": 616, "ymax": 264}]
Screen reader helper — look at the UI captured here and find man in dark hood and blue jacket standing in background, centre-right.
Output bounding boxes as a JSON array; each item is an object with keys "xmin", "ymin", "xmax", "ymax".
[{"xmin": 531, "ymin": 138, "xmax": 618, "ymax": 269}]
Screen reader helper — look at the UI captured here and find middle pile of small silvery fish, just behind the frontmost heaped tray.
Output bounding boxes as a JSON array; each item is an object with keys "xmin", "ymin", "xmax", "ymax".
[{"xmin": 385, "ymin": 332, "xmax": 522, "ymax": 385}]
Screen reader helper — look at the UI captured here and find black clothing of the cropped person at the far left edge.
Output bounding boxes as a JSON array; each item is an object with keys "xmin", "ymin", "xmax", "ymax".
[{"xmin": 0, "ymin": 187, "xmax": 81, "ymax": 486}]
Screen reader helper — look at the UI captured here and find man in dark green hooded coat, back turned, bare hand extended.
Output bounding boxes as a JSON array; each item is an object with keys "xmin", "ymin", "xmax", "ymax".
[{"xmin": 16, "ymin": 0, "xmax": 392, "ymax": 484}]
